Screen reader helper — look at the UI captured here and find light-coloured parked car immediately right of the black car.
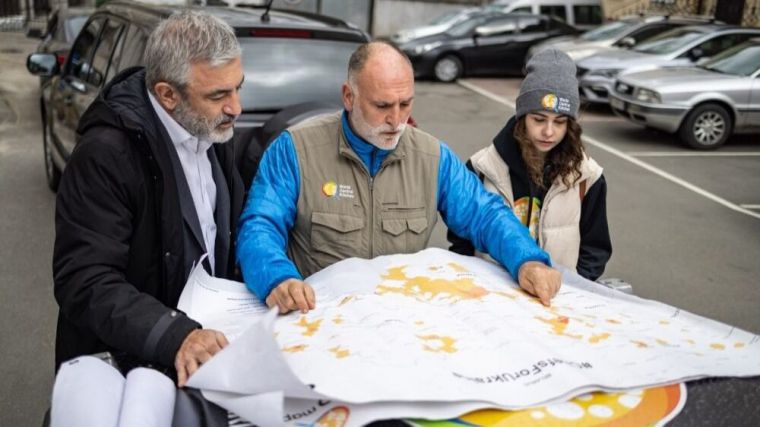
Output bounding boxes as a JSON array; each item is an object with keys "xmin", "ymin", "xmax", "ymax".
[{"xmin": 525, "ymin": 15, "xmax": 715, "ymax": 62}]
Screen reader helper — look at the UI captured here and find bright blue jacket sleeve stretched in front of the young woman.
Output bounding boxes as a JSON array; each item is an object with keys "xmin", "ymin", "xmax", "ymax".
[{"xmin": 438, "ymin": 142, "xmax": 550, "ymax": 280}]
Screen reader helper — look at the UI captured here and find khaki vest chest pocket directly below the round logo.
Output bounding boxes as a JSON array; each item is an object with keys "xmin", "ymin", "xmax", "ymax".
[{"xmin": 311, "ymin": 212, "xmax": 366, "ymax": 268}]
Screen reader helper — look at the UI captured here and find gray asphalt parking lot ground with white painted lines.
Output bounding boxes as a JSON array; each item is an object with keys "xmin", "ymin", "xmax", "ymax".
[{"xmin": 0, "ymin": 28, "xmax": 760, "ymax": 425}]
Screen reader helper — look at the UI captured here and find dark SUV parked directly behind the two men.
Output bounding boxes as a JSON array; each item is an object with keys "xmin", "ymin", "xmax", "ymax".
[{"xmin": 27, "ymin": 0, "xmax": 369, "ymax": 190}]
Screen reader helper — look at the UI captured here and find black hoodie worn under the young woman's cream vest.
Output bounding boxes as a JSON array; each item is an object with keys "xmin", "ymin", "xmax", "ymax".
[{"xmin": 447, "ymin": 117, "xmax": 612, "ymax": 280}]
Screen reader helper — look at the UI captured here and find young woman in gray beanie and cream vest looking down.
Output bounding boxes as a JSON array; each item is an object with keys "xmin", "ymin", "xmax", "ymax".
[{"xmin": 448, "ymin": 49, "xmax": 612, "ymax": 280}]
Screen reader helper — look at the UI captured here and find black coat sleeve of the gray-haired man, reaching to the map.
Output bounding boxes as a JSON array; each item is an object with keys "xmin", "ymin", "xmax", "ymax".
[{"xmin": 53, "ymin": 130, "xmax": 200, "ymax": 367}]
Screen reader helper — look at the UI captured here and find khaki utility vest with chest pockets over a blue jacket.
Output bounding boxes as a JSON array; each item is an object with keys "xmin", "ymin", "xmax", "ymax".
[{"xmin": 288, "ymin": 113, "xmax": 441, "ymax": 277}]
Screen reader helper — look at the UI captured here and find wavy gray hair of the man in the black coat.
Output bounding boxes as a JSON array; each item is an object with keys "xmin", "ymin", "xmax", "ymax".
[{"xmin": 144, "ymin": 10, "xmax": 241, "ymax": 92}]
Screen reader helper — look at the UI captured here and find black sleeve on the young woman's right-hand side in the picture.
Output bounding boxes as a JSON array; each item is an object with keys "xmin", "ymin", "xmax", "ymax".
[{"xmin": 576, "ymin": 175, "xmax": 612, "ymax": 280}]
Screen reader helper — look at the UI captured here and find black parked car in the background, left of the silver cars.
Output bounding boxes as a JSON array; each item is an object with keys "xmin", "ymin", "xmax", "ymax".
[{"xmin": 399, "ymin": 13, "xmax": 579, "ymax": 82}]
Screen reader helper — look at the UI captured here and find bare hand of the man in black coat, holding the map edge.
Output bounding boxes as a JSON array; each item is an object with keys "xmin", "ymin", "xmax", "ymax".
[{"xmin": 174, "ymin": 329, "xmax": 228, "ymax": 387}]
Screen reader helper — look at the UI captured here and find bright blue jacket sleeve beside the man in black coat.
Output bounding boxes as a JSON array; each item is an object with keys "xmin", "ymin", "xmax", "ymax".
[{"xmin": 237, "ymin": 132, "xmax": 303, "ymax": 302}]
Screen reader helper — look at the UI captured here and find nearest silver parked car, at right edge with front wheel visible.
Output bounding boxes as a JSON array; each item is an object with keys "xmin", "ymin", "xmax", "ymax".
[{"xmin": 610, "ymin": 37, "xmax": 760, "ymax": 150}]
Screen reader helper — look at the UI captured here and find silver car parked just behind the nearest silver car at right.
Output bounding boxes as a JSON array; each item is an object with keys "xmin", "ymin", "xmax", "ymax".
[{"xmin": 577, "ymin": 24, "xmax": 760, "ymax": 104}]
